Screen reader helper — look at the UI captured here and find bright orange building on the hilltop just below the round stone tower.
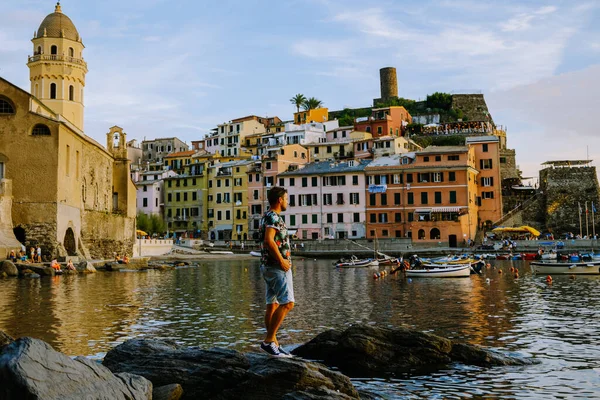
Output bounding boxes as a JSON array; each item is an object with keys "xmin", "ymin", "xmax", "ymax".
[{"xmin": 354, "ymin": 106, "xmax": 412, "ymax": 138}]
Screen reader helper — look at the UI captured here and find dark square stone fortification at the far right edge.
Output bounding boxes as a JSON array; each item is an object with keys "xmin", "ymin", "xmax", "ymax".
[{"xmin": 540, "ymin": 167, "xmax": 600, "ymax": 235}]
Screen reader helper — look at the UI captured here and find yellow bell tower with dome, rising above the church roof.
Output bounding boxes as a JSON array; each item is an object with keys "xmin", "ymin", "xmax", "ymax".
[{"xmin": 27, "ymin": 1, "xmax": 87, "ymax": 130}]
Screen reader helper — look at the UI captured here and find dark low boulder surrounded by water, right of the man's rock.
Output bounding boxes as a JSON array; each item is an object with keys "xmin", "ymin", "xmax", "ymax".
[{"xmin": 293, "ymin": 325, "xmax": 532, "ymax": 377}]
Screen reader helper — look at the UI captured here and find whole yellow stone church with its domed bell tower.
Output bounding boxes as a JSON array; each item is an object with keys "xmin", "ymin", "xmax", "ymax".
[{"xmin": 0, "ymin": 5, "xmax": 136, "ymax": 258}]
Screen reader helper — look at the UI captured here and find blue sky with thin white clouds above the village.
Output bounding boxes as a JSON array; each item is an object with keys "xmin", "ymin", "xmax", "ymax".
[{"xmin": 0, "ymin": 0, "xmax": 600, "ymax": 181}]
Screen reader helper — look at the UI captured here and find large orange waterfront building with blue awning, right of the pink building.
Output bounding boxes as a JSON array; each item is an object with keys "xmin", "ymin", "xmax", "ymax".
[{"xmin": 365, "ymin": 146, "xmax": 482, "ymax": 247}]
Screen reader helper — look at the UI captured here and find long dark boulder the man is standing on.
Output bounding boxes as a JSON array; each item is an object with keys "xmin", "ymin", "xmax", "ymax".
[{"xmin": 103, "ymin": 339, "xmax": 359, "ymax": 400}]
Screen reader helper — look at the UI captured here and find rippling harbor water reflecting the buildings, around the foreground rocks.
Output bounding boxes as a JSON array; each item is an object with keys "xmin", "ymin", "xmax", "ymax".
[{"xmin": 0, "ymin": 259, "xmax": 600, "ymax": 399}]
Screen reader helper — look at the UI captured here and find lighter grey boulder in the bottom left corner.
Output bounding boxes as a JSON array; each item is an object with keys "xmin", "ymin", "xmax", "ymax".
[{"xmin": 0, "ymin": 337, "xmax": 152, "ymax": 400}]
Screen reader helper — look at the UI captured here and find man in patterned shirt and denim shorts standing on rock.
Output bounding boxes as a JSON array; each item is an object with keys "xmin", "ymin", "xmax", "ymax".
[{"xmin": 260, "ymin": 186, "xmax": 294, "ymax": 357}]
